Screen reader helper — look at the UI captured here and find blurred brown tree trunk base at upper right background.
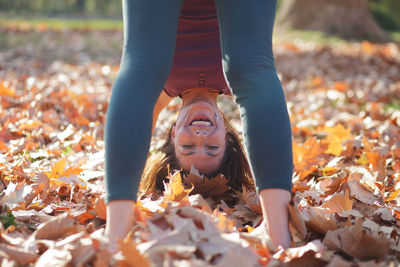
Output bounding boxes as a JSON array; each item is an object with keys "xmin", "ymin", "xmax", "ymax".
[{"xmin": 276, "ymin": 0, "xmax": 390, "ymax": 41}]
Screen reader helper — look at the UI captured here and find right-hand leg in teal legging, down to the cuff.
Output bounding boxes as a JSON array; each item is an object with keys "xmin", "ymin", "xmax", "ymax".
[{"xmin": 215, "ymin": 0, "xmax": 293, "ymax": 191}]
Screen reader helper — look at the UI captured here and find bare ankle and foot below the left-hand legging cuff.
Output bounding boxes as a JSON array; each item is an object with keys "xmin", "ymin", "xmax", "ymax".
[{"xmin": 105, "ymin": 200, "xmax": 135, "ymax": 253}]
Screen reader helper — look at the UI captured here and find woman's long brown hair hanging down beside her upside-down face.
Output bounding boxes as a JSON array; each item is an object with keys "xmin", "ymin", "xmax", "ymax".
[{"xmin": 138, "ymin": 117, "xmax": 255, "ymax": 198}]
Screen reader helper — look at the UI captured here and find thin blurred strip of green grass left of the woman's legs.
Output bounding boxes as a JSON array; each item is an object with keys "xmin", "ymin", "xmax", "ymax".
[{"xmin": 0, "ymin": 15, "xmax": 123, "ymax": 30}]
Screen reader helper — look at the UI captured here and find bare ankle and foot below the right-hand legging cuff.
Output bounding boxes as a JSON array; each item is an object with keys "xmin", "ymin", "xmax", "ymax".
[{"xmin": 259, "ymin": 188, "xmax": 291, "ymax": 248}]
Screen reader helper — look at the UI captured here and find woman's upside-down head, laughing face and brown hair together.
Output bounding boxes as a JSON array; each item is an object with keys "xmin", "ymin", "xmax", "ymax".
[{"xmin": 139, "ymin": 107, "xmax": 255, "ymax": 199}]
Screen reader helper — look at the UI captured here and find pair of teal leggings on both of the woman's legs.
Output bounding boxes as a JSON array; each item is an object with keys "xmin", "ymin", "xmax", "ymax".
[{"xmin": 105, "ymin": 0, "xmax": 293, "ymax": 203}]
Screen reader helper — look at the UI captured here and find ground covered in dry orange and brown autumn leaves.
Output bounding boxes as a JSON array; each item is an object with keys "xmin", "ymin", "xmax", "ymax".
[{"xmin": 0, "ymin": 21, "xmax": 400, "ymax": 266}]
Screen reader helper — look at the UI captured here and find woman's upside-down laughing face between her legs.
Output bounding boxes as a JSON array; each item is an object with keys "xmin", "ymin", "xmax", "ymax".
[{"xmin": 172, "ymin": 100, "xmax": 226, "ymax": 174}]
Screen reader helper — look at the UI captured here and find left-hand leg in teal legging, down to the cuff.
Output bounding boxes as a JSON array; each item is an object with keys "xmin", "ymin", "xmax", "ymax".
[{"xmin": 105, "ymin": 0, "xmax": 182, "ymax": 202}]
